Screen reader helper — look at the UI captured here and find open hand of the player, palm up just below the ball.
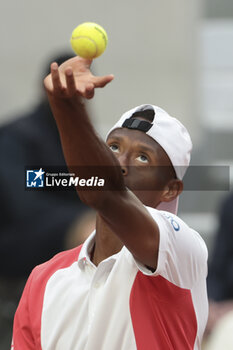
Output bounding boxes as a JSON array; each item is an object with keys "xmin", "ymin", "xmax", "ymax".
[{"xmin": 44, "ymin": 56, "xmax": 114, "ymax": 99}]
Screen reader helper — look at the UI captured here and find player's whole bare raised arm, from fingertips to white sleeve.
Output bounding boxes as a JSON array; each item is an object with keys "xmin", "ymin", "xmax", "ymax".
[{"xmin": 44, "ymin": 57, "xmax": 159, "ymax": 269}]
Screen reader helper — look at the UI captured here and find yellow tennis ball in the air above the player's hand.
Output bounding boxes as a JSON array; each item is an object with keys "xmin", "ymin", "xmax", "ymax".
[{"xmin": 70, "ymin": 22, "xmax": 108, "ymax": 59}]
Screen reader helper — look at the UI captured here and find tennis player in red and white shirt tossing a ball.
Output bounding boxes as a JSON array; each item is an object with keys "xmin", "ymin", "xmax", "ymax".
[{"xmin": 12, "ymin": 57, "xmax": 208, "ymax": 350}]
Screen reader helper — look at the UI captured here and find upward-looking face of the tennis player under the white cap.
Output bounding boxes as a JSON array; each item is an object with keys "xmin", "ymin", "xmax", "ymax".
[{"xmin": 107, "ymin": 128, "xmax": 175, "ymax": 207}]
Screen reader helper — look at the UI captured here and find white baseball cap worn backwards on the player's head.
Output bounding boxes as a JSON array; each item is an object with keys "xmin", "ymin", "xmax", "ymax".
[{"xmin": 107, "ymin": 104, "xmax": 192, "ymax": 214}]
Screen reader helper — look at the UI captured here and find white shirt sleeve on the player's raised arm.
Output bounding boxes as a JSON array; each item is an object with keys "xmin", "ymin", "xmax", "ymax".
[{"xmin": 135, "ymin": 207, "xmax": 208, "ymax": 289}]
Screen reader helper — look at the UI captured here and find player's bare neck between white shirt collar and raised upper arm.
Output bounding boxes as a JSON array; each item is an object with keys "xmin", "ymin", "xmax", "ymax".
[{"xmin": 91, "ymin": 214, "xmax": 123, "ymax": 266}]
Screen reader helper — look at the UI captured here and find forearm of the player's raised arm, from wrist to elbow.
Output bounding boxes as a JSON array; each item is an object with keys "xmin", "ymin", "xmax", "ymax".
[{"xmin": 48, "ymin": 93, "xmax": 125, "ymax": 205}]
